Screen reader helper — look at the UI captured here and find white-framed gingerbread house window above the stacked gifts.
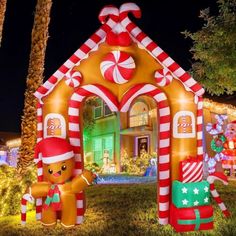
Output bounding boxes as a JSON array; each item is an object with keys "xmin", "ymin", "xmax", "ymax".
[{"xmin": 173, "ymin": 111, "xmax": 196, "ymax": 138}]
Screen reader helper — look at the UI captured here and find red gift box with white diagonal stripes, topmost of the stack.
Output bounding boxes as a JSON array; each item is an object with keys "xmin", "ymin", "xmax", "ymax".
[{"xmin": 179, "ymin": 157, "xmax": 203, "ymax": 183}]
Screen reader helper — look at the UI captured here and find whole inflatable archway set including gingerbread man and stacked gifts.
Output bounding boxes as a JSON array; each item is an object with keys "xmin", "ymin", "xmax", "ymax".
[{"xmin": 18, "ymin": 3, "xmax": 230, "ymax": 231}]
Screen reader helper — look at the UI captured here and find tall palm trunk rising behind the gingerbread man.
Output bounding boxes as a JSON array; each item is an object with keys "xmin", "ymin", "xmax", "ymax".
[{"xmin": 17, "ymin": 0, "xmax": 52, "ymax": 173}]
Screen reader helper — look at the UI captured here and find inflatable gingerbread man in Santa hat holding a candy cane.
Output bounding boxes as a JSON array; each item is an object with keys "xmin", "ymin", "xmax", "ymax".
[{"xmin": 21, "ymin": 137, "xmax": 94, "ymax": 228}]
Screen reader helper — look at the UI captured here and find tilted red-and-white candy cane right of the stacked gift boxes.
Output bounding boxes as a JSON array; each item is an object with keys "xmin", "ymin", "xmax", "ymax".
[{"xmin": 207, "ymin": 172, "xmax": 230, "ymax": 217}]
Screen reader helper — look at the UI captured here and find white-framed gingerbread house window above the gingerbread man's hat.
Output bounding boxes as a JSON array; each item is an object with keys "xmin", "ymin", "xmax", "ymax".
[{"xmin": 43, "ymin": 113, "xmax": 66, "ymax": 138}]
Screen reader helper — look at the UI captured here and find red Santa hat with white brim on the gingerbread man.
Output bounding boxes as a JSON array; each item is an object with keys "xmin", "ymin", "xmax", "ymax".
[{"xmin": 34, "ymin": 137, "xmax": 74, "ymax": 164}]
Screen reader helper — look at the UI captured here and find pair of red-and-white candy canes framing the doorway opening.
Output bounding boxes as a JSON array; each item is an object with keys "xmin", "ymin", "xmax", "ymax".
[{"xmin": 68, "ymin": 84, "xmax": 171, "ymax": 224}]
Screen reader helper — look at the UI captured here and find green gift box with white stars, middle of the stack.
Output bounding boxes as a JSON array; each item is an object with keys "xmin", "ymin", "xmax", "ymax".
[{"xmin": 172, "ymin": 180, "xmax": 210, "ymax": 208}]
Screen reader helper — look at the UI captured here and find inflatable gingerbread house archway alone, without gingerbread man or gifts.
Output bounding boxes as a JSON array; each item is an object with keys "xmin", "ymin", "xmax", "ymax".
[{"xmin": 32, "ymin": 3, "xmax": 212, "ymax": 230}]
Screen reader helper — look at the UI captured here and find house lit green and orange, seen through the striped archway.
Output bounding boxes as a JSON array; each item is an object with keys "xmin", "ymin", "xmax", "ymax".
[{"xmin": 84, "ymin": 96, "xmax": 158, "ymax": 172}]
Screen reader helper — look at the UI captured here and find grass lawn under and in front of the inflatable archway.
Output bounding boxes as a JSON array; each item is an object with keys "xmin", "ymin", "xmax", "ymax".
[{"xmin": 0, "ymin": 181, "xmax": 236, "ymax": 236}]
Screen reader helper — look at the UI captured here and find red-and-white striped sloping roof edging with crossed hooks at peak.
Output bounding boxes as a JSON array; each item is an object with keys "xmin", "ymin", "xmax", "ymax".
[{"xmin": 34, "ymin": 3, "xmax": 204, "ymax": 102}]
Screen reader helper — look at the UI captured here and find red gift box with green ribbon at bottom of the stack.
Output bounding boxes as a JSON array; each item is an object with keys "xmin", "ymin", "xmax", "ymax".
[{"xmin": 170, "ymin": 204, "xmax": 213, "ymax": 232}]
